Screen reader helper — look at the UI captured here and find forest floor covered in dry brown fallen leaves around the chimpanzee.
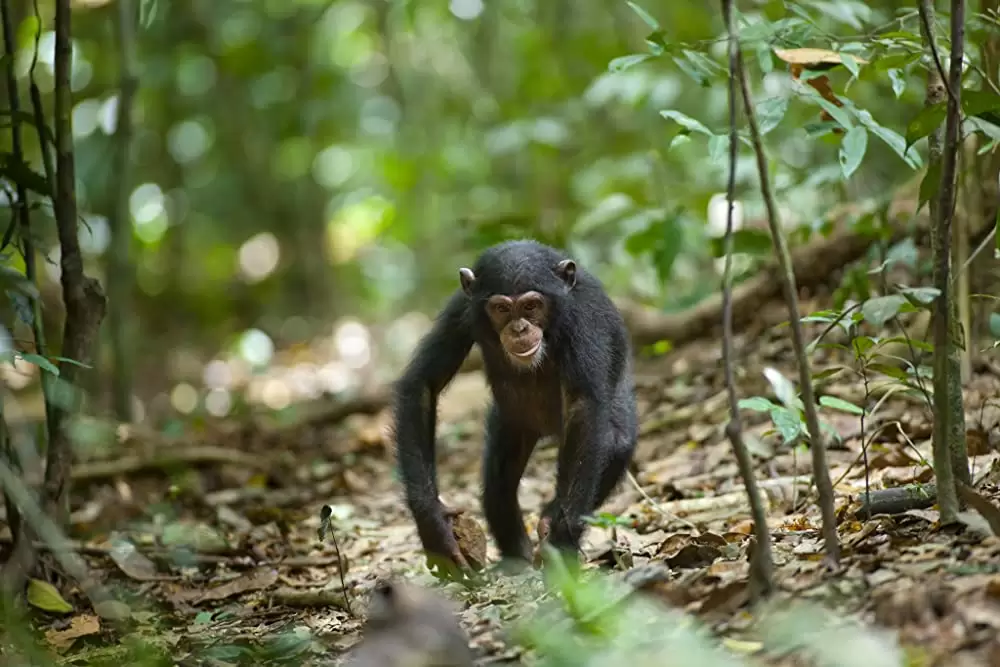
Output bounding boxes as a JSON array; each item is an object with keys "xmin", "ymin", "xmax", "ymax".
[{"xmin": 5, "ymin": 300, "xmax": 1000, "ymax": 665}]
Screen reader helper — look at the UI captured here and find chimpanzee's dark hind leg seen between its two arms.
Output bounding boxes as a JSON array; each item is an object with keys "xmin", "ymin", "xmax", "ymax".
[{"xmin": 483, "ymin": 404, "xmax": 538, "ymax": 560}]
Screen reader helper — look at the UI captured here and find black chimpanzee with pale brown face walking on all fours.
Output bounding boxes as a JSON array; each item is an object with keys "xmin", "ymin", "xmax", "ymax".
[{"xmin": 395, "ymin": 240, "xmax": 638, "ymax": 574}]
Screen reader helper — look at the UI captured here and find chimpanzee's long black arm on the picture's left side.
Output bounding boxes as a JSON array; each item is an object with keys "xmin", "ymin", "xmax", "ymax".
[{"xmin": 394, "ymin": 290, "xmax": 473, "ymax": 569}]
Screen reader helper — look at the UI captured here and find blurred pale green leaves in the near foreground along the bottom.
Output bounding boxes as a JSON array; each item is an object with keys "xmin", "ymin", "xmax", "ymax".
[{"xmin": 518, "ymin": 554, "xmax": 906, "ymax": 667}]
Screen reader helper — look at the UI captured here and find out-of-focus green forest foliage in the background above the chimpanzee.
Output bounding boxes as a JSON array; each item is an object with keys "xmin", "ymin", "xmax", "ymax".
[{"xmin": 0, "ymin": 0, "xmax": 997, "ymax": 408}]
